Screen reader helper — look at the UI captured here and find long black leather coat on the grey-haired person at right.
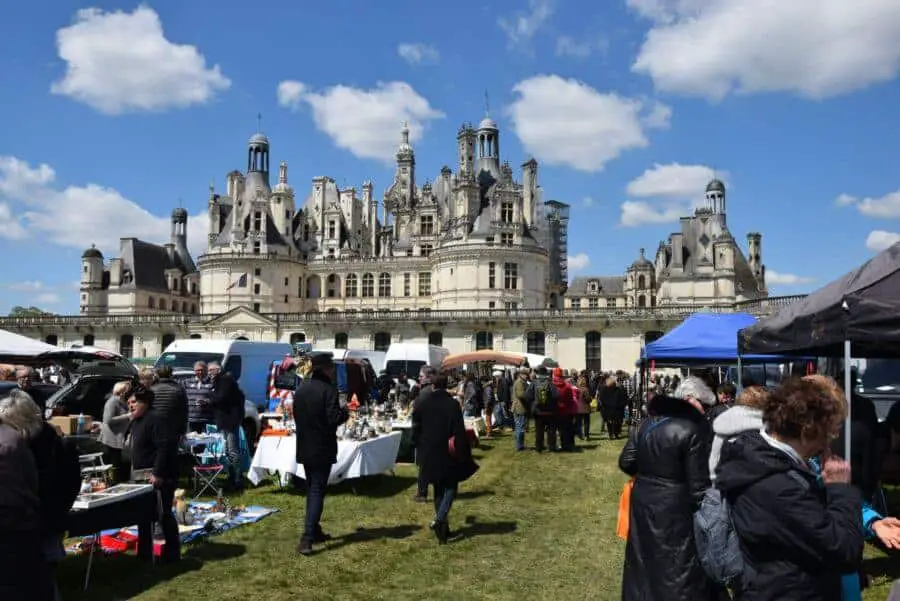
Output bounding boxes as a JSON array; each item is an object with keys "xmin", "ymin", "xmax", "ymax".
[{"xmin": 619, "ymin": 396, "xmax": 724, "ymax": 601}]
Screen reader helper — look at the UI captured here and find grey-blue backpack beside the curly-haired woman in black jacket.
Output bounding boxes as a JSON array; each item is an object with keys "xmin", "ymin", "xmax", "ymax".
[{"xmin": 694, "ymin": 470, "xmax": 809, "ymax": 586}]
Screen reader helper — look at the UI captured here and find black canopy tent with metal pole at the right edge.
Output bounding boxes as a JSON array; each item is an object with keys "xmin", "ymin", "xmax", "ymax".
[{"xmin": 738, "ymin": 242, "xmax": 900, "ymax": 457}]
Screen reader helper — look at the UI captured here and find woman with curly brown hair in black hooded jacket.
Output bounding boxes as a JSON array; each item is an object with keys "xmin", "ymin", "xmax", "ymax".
[{"xmin": 716, "ymin": 381, "xmax": 864, "ymax": 601}]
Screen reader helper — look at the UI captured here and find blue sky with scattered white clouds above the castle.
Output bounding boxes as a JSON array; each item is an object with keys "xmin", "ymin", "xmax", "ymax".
[{"xmin": 0, "ymin": 0, "xmax": 900, "ymax": 313}]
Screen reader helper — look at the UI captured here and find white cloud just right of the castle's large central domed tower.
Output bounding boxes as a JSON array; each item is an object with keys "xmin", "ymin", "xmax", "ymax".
[{"xmin": 507, "ymin": 75, "xmax": 668, "ymax": 172}]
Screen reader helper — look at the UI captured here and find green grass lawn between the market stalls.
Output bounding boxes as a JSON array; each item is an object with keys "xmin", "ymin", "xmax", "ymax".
[{"xmin": 59, "ymin": 418, "xmax": 900, "ymax": 601}]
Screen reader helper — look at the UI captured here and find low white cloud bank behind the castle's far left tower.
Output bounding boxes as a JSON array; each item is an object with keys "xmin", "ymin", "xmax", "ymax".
[{"xmin": 0, "ymin": 156, "xmax": 208, "ymax": 255}]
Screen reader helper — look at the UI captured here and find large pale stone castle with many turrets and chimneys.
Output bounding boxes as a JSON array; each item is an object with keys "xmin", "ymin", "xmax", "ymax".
[{"xmin": 45, "ymin": 117, "xmax": 787, "ymax": 369}]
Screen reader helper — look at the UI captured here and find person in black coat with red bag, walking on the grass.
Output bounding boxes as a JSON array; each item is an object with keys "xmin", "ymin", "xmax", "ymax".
[{"xmin": 412, "ymin": 375, "xmax": 478, "ymax": 545}]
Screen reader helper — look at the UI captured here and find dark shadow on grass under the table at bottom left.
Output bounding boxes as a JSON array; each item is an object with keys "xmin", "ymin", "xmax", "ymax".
[{"xmin": 56, "ymin": 540, "xmax": 246, "ymax": 601}]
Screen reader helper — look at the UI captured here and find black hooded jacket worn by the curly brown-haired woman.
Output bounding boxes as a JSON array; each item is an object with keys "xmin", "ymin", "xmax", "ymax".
[{"xmin": 716, "ymin": 432, "xmax": 864, "ymax": 601}]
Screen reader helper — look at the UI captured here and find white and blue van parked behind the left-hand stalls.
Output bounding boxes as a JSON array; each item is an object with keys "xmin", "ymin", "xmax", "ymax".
[{"xmin": 156, "ymin": 338, "xmax": 292, "ymax": 409}]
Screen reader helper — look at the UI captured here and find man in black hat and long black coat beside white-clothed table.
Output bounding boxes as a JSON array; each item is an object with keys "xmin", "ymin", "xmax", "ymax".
[{"xmin": 294, "ymin": 352, "xmax": 350, "ymax": 555}]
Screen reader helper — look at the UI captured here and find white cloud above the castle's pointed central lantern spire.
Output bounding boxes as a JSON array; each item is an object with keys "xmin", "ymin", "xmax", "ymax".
[{"xmin": 278, "ymin": 80, "xmax": 444, "ymax": 163}]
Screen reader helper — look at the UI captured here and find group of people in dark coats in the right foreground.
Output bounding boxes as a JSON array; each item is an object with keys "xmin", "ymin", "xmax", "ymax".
[{"xmin": 619, "ymin": 375, "xmax": 900, "ymax": 601}]
